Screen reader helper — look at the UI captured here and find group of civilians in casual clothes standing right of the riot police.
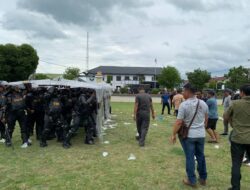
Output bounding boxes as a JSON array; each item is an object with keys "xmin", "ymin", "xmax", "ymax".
[{"xmin": 134, "ymin": 84, "xmax": 250, "ymax": 190}]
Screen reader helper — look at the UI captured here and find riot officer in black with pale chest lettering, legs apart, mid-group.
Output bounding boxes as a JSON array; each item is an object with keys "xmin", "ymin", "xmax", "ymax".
[{"xmin": 40, "ymin": 87, "xmax": 68, "ymax": 147}]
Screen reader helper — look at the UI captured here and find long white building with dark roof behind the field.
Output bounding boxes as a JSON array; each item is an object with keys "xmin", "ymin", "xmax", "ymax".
[{"xmin": 89, "ymin": 66, "xmax": 162, "ymax": 89}]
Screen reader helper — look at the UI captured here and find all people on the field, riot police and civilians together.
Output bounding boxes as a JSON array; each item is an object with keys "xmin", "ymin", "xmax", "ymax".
[{"xmin": 0, "ymin": 80, "xmax": 250, "ymax": 190}]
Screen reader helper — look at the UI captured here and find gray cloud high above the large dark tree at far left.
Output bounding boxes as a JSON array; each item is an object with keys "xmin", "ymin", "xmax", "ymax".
[{"xmin": 2, "ymin": 10, "xmax": 66, "ymax": 39}]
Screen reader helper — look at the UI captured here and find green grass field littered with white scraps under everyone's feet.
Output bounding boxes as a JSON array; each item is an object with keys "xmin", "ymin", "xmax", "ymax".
[{"xmin": 0, "ymin": 103, "xmax": 250, "ymax": 190}]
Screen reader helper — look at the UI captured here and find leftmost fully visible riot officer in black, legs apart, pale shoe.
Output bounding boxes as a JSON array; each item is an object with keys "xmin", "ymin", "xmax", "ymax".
[{"xmin": 6, "ymin": 87, "xmax": 30, "ymax": 146}]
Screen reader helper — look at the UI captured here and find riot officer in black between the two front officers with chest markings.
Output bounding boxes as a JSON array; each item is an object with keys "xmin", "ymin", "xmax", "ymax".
[{"xmin": 26, "ymin": 88, "xmax": 44, "ymax": 140}]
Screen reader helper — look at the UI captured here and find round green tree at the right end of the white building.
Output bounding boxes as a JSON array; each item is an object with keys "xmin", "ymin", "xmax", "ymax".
[{"xmin": 158, "ymin": 66, "xmax": 181, "ymax": 89}]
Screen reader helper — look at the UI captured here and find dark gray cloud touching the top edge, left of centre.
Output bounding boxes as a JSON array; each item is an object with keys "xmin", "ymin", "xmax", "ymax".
[{"xmin": 18, "ymin": 0, "xmax": 149, "ymax": 27}]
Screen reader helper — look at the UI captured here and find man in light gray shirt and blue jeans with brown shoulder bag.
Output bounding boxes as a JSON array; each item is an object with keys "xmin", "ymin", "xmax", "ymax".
[{"xmin": 171, "ymin": 84, "xmax": 208, "ymax": 188}]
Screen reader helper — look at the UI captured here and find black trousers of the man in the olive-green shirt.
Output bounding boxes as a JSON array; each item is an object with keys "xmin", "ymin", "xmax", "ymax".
[{"xmin": 231, "ymin": 141, "xmax": 250, "ymax": 190}]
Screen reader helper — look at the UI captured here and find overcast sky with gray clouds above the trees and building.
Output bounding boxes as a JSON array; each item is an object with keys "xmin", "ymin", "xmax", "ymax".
[{"xmin": 0, "ymin": 0, "xmax": 250, "ymax": 76}]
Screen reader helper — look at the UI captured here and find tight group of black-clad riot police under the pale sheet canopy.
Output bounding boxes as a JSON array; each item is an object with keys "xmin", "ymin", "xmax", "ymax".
[{"xmin": 0, "ymin": 84, "xmax": 98, "ymax": 148}]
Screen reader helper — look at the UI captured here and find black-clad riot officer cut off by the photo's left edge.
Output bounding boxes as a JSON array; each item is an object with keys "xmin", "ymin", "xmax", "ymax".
[{"xmin": 0, "ymin": 85, "xmax": 6, "ymax": 139}]
